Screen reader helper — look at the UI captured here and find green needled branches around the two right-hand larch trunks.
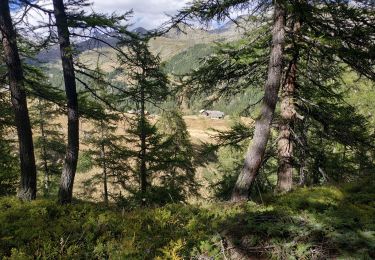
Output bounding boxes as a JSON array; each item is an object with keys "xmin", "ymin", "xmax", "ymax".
[{"xmin": 177, "ymin": 0, "xmax": 375, "ymax": 190}]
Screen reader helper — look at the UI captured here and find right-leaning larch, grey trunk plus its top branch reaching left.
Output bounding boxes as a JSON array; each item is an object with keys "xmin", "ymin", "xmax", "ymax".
[{"xmin": 174, "ymin": 0, "xmax": 287, "ymax": 202}]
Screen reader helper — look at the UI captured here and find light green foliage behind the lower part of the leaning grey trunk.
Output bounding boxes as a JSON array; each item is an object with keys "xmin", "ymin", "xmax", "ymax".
[{"xmin": 201, "ymin": 118, "xmax": 276, "ymax": 201}]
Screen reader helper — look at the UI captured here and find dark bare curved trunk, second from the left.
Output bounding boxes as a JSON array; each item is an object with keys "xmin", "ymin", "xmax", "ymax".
[{"xmin": 53, "ymin": 0, "xmax": 79, "ymax": 204}]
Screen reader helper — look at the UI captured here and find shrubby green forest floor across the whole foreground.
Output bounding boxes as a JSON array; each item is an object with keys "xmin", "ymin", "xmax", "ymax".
[{"xmin": 0, "ymin": 178, "xmax": 375, "ymax": 259}]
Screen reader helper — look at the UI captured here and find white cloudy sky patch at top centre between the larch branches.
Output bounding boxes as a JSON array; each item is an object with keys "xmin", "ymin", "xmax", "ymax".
[{"xmin": 91, "ymin": 0, "xmax": 191, "ymax": 29}]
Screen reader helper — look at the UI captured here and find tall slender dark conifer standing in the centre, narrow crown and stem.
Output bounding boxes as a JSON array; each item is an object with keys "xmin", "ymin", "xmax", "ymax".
[{"xmin": 119, "ymin": 35, "xmax": 168, "ymax": 197}]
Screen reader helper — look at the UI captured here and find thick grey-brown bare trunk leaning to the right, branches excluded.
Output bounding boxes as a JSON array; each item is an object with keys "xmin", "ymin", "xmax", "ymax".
[{"xmin": 231, "ymin": 0, "xmax": 285, "ymax": 201}]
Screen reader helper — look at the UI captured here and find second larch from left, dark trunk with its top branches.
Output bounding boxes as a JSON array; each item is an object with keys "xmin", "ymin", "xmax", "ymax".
[{"xmin": 21, "ymin": 0, "xmax": 133, "ymax": 204}]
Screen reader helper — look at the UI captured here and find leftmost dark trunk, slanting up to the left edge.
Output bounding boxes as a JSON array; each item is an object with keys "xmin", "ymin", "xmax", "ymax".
[{"xmin": 0, "ymin": 0, "xmax": 36, "ymax": 200}]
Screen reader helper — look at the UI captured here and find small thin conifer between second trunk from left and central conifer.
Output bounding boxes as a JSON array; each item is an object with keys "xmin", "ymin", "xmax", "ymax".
[{"xmin": 83, "ymin": 66, "xmax": 127, "ymax": 205}]
